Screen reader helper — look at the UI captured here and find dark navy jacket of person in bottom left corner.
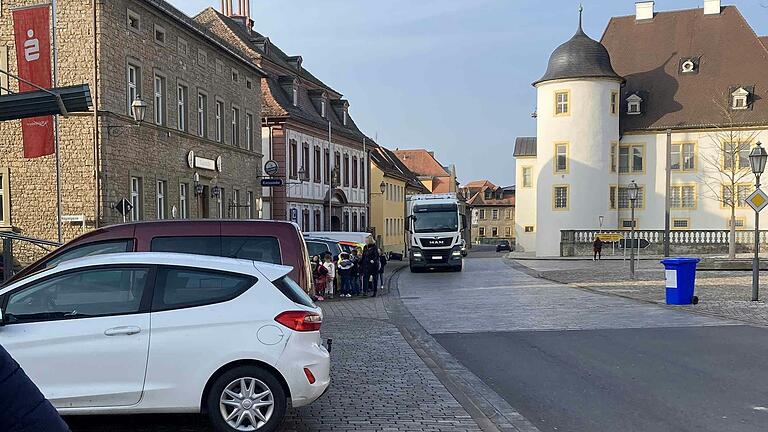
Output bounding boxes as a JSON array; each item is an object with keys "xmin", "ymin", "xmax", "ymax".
[{"xmin": 0, "ymin": 345, "xmax": 70, "ymax": 432}]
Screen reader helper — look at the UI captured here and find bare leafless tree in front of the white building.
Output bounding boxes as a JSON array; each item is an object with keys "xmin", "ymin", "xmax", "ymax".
[{"xmin": 700, "ymin": 93, "xmax": 760, "ymax": 259}]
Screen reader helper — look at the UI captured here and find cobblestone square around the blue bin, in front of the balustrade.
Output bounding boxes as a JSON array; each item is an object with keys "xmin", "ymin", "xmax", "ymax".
[{"xmin": 512, "ymin": 260, "xmax": 768, "ymax": 326}]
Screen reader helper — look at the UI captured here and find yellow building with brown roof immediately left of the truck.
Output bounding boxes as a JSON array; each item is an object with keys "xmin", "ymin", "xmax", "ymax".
[{"xmin": 371, "ymin": 146, "xmax": 429, "ymax": 255}]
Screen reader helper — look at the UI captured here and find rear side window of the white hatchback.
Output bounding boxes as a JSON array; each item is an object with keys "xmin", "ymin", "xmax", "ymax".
[{"xmin": 152, "ymin": 267, "xmax": 256, "ymax": 311}]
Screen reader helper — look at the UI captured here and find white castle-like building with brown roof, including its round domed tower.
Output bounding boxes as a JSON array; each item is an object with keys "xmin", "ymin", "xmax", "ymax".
[{"xmin": 514, "ymin": 0, "xmax": 768, "ymax": 256}]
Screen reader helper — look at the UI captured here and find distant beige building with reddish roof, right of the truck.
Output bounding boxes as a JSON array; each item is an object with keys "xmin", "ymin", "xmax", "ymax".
[{"xmin": 461, "ymin": 180, "xmax": 515, "ymax": 245}]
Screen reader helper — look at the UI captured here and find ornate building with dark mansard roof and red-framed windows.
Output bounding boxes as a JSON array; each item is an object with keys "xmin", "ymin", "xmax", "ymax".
[{"xmin": 195, "ymin": 4, "xmax": 368, "ymax": 231}]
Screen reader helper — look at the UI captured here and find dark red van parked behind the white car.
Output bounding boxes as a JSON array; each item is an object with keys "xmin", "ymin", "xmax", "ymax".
[{"xmin": 9, "ymin": 219, "xmax": 312, "ymax": 291}]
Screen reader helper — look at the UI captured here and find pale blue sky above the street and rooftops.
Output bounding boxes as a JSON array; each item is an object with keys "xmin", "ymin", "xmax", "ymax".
[{"xmin": 169, "ymin": 0, "xmax": 768, "ymax": 186}]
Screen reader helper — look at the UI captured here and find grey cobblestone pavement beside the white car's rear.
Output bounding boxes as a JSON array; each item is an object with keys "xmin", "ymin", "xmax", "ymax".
[{"xmin": 67, "ymin": 263, "xmax": 481, "ymax": 432}]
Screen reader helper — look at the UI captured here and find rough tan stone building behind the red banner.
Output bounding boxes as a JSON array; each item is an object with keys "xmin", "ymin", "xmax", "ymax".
[{"xmin": 0, "ymin": 0, "xmax": 264, "ymax": 250}]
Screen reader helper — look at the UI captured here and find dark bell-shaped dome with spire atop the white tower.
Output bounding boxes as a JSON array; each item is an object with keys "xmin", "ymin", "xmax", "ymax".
[{"xmin": 533, "ymin": 10, "xmax": 624, "ymax": 86}]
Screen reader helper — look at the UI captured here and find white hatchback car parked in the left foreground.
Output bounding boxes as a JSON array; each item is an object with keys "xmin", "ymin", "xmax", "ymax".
[{"xmin": 0, "ymin": 252, "xmax": 330, "ymax": 432}]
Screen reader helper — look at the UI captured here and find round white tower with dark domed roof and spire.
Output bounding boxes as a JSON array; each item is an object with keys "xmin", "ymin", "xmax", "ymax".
[{"xmin": 533, "ymin": 8, "xmax": 624, "ymax": 256}]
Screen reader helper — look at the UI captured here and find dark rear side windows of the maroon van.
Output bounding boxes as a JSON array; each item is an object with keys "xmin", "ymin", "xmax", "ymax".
[{"xmin": 150, "ymin": 236, "xmax": 282, "ymax": 264}]
